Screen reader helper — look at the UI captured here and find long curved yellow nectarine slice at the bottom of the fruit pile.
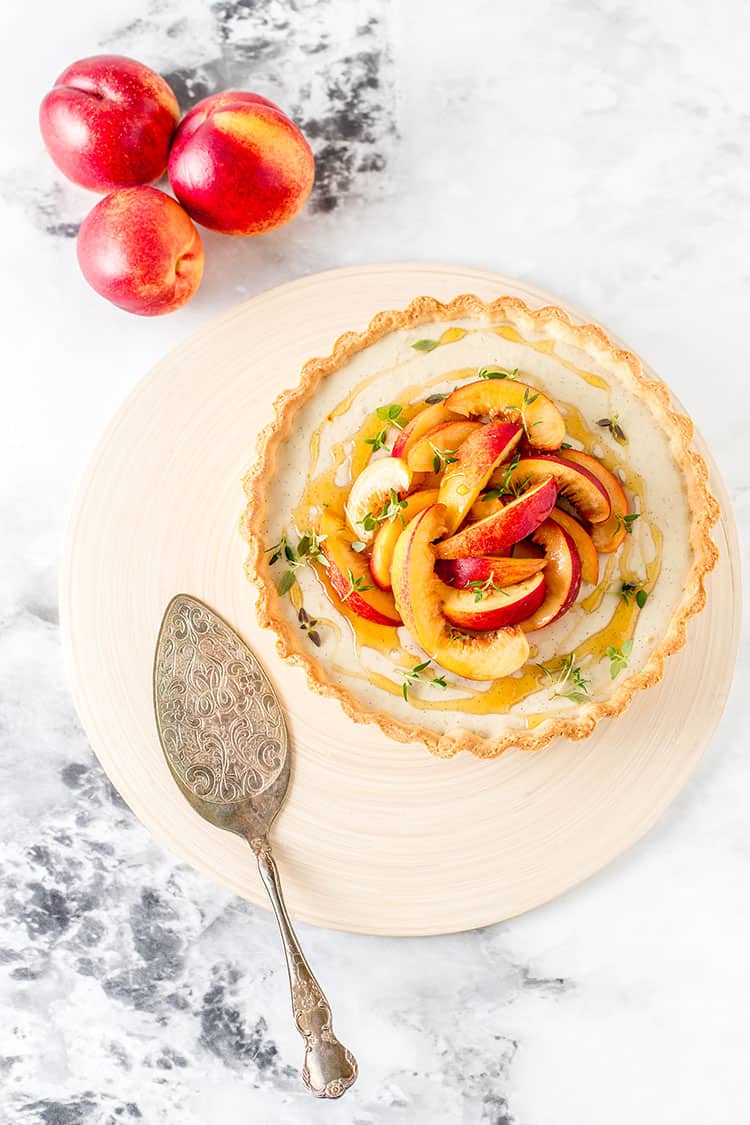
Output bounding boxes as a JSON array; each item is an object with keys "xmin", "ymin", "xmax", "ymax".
[{"xmin": 391, "ymin": 504, "xmax": 528, "ymax": 680}]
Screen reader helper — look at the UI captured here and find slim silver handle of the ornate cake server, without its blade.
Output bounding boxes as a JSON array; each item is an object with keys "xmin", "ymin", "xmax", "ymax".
[{"xmin": 250, "ymin": 837, "xmax": 358, "ymax": 1098}]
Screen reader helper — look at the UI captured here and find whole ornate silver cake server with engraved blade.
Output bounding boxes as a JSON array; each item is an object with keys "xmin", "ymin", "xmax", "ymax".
[{"xmin": 154, "ymin": 594, "xmax": 356, "ymax": 1098}]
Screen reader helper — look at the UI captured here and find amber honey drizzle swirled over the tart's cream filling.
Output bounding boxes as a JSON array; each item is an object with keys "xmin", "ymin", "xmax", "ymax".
[{"xmin": 292, "ymin": 326, "xmax": 662, "ymax": 727}]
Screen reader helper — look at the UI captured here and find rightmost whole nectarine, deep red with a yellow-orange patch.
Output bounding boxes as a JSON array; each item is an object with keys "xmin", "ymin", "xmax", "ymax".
[{"xmin": 169, "ymin": 91, "xmax": 315, "ymax": 235}]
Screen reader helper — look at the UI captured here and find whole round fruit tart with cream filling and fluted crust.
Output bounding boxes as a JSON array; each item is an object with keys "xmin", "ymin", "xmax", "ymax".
[{"xmin": 242, "ymin": 295, "xmax": 719, "ymax": 757}]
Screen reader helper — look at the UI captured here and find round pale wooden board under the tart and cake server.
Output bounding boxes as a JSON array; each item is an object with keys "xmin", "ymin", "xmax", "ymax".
[{"xmin": 62, "ymin": 263, "xmax": 740, "ymax": 935}]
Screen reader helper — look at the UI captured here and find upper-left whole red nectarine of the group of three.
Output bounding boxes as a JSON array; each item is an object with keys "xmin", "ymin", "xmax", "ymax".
[{"xmin": 39, "ymin": 55, "xmax": 180, "ymax": 191}]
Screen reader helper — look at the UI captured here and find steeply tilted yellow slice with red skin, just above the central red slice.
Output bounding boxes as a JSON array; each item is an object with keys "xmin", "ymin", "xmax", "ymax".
[{"xmin": 440, "ymin": 422, "xmax": 523, "ymax": 531}]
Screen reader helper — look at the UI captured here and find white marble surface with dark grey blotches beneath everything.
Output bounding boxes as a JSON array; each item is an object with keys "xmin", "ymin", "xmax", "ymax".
[{"xmin": 0, "ymin": 0, "xmax": 750, "ymax": 1125}]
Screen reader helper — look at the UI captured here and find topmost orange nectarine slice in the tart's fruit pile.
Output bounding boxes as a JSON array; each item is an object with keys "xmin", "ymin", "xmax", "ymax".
[{"xmin": 445, "ymin": 379, "xmax": 566, "ymax": 449}]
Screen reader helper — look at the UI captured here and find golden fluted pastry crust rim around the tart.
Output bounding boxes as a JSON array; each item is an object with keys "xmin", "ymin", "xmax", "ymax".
[{"xmin": 241, "ymin": 294, "xmax": 720, "ymax": 758}]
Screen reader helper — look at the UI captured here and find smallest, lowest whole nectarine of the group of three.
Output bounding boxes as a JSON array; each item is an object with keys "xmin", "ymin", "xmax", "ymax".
[{"xmin": 78, "ymin": 187, "xmax": 204, "ymax": 316}]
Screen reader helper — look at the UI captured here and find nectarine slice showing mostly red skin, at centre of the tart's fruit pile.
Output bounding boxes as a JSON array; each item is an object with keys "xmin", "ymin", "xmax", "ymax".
[{"xmin": 436, "ymin": 477, "xmax": 558, "ymax": 559}]
